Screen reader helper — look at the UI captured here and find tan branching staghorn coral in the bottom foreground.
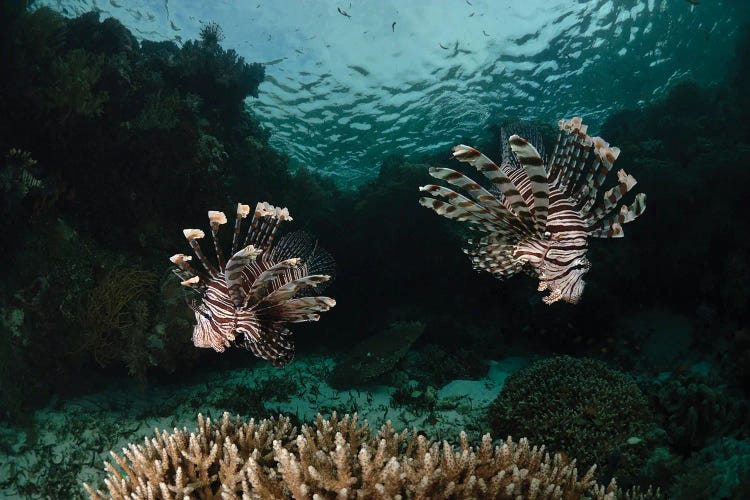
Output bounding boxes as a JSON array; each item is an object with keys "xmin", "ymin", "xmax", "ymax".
[{"xmin": 84, "ymin": 413, "xmax": 648, "ymax": 500}]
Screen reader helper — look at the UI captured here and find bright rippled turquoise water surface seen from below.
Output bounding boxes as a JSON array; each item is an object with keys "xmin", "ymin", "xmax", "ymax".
[{"xmin": 36, "ymin": 0, "xmax": 750, "ymax": 186}]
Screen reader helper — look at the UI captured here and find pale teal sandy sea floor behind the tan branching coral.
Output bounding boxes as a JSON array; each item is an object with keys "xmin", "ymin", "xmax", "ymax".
[{"xmin": 0, "ymin": 356, "xmax": 528, "ymax": 498}]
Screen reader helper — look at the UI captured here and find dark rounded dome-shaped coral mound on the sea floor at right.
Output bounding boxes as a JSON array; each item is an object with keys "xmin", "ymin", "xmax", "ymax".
[{"xmin": 487, "ymin": 356, "xmax": 653, "ymax": 482}]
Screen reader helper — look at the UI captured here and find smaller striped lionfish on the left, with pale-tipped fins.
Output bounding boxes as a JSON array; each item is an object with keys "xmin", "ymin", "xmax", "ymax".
[{"xmin": 170, "ymin": 202, "xmax": 336, "ymax": 366}]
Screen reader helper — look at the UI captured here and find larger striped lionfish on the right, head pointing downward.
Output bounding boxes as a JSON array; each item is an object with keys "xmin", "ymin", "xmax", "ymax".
[{"xmin": 419, "ymin": 118, "xmax": 646, "ymax": 304}]
